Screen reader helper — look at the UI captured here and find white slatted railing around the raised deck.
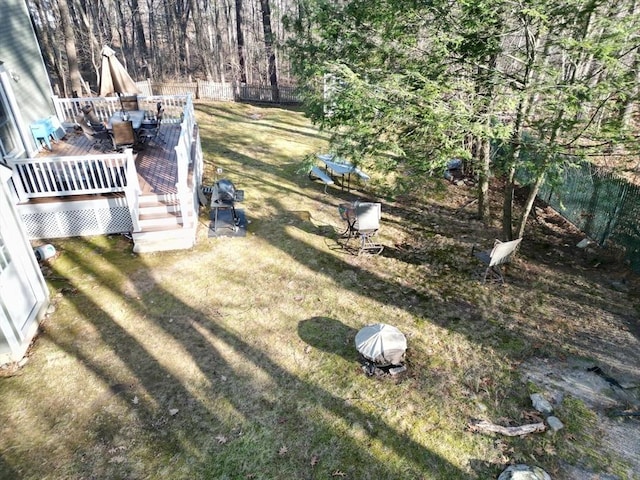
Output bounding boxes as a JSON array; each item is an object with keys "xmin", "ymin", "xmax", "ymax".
[{"xmin": 11, "ymin": 95, "xmax": 202, "ymax": 231}]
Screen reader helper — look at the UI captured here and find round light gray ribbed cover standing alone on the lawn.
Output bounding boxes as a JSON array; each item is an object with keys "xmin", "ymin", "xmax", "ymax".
[{"xmin": 356, "ymin": 323, "xmax": 407, "ymax": 366}]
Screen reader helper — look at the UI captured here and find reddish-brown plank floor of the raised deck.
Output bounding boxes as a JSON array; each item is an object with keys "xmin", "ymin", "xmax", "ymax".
[{"xmin": 37, "ymin": 123, "xmax": 180, "ymax": 195}]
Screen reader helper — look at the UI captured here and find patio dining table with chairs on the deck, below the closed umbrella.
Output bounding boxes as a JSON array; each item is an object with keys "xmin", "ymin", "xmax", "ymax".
[{"xmin": 76, "ymin": 96, "xmax": 164, "ymax": 152}]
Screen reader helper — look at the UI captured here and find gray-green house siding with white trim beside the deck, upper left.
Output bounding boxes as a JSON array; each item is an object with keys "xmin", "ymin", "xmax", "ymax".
[{"xmin": 0, "ymin": 0, "xmax": 55, "ymax": 154}]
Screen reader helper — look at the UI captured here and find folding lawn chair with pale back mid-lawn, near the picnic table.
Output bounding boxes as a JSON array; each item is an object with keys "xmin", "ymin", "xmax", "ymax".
[{"xmin": 339, "ymin": 202, "xmax": 384, "ymax": 255}]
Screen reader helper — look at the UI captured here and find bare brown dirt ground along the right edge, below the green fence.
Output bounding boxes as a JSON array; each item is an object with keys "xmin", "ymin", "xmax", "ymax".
[{"xmin": 436, "ymin": 181, "xmax": 640, "ymax": 480}]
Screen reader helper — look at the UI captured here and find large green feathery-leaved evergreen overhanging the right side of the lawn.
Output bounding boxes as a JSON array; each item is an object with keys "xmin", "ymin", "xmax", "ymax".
[{"xmin": 291, "ymin": 0, "xmax": 638, "ymax": 238}]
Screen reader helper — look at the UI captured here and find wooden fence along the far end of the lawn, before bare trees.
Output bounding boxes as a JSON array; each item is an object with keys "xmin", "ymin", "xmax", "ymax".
[{"xmin": 136, "ymin": 80, "xmax": 302, "ymax": 105}]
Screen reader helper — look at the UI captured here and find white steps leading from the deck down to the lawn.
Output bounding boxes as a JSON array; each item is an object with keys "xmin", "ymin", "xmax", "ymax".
[{"xmin": 132, "ymin": 194, "xmax": 198, "ymax": 253}]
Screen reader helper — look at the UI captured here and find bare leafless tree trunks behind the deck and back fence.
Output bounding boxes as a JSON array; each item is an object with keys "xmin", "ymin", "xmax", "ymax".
[{"xmin": 27, "ymin": 0, "xmax": 297, "ymax": 97}]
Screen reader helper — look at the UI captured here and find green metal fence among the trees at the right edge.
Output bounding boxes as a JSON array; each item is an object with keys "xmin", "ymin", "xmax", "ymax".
[{"xmin": 538, "ymin": 162, "xmax": 640, "ymax": 273}]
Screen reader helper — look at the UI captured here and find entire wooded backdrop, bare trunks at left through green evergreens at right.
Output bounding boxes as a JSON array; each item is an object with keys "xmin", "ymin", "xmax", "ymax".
[{"xmin": 26, "ymin": 0, "xmax": 640, "ymax": 246}]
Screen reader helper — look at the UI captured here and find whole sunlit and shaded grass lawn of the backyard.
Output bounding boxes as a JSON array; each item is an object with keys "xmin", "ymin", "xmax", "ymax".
[{"xmin": 0, "ymin": 103, "xmax": 640, "ymax": 480}]
